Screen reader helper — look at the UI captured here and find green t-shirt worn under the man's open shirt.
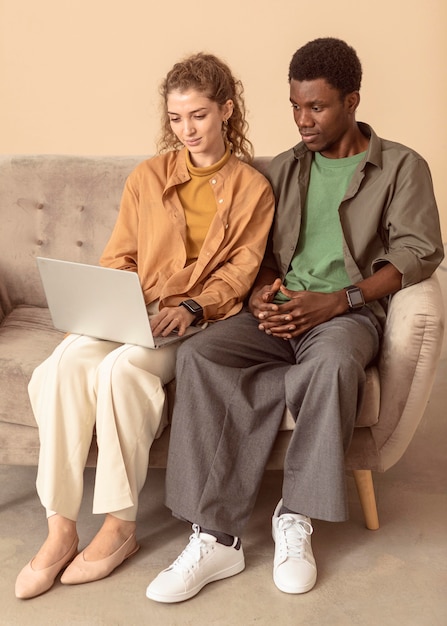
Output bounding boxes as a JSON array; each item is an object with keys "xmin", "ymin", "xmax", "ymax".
[{"xmin": 275, "ymin": 152, "xmax": 365, "ymax": 303}]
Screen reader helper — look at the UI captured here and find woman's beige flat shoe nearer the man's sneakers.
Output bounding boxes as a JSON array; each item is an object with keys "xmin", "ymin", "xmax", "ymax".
[{"xmin": 61, "ymin": 533, "xmax": 140, "ymax": 585}]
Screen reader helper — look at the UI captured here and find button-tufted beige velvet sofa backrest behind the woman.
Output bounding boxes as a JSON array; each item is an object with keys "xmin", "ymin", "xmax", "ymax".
[{"xmin": 0, "ymin": 155, "xmax": 270, "ymax": 315}]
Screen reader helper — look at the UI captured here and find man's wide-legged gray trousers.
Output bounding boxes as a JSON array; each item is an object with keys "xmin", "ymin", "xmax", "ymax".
[{"xmin": 166, "ymin": 311, "xmax": 379, "ymax": 536}]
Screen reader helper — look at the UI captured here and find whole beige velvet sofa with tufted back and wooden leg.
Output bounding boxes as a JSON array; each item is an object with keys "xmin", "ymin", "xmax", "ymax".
[{"xmin": 0, "ymin": 155, "xmax": 443, "ymax": 528}]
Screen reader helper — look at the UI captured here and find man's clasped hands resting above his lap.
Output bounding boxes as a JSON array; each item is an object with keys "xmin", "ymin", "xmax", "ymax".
[{"xmin": 249, "ymin": 278, "xmax": 338, "ymax": 339}]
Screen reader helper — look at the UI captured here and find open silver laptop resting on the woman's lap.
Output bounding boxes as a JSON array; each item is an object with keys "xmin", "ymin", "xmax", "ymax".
[{"xmin": 37, "ymin": 257, "xmax": 201, "ymax": 349}]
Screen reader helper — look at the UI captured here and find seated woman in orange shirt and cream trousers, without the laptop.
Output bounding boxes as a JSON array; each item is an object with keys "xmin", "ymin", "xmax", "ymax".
[{"xmin": 16, "ymin": 54, "xmax": 274, "ymax": 598}]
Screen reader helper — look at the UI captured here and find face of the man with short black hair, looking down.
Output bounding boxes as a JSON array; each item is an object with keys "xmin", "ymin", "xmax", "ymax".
[{"xmin": 290, "ymin": 78, "xmax": 359, "ymax": 159}]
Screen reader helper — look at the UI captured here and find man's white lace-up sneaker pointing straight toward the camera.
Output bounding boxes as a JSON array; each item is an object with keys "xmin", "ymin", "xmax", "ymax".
[{"xmin": 272, "ymin": 500, "xmax": 317, "ymax": 593}]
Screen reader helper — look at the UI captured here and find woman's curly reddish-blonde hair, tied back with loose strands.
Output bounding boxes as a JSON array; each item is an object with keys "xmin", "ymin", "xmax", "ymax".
[{"xmin": 157, "ymin": 52, "xmax": 253, "ymax": 162}]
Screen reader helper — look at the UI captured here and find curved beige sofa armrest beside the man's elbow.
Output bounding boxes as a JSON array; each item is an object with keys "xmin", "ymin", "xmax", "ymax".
[{"xmin": 372, "ymin": 275, "xmax": 444, "ymax": 471}]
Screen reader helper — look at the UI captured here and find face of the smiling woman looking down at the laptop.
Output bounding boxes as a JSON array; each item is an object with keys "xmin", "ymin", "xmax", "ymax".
[{"xmin": 166, "ymin": 89, "xmax": 233, "ymax": 167}]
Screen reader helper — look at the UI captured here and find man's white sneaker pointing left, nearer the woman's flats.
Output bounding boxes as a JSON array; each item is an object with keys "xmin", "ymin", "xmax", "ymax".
[{"xmin": 146, "ymin": 524, "xmax": 245, "ymax": 602}]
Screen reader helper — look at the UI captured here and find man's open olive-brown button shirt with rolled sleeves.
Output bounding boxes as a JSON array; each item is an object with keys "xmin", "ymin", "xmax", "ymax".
[{"xmin": 263, "ymin": 122, "xmax": 444, "ymax": 323}]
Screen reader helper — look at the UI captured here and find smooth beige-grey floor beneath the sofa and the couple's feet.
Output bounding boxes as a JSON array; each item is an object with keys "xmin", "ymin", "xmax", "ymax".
[{"xmin": 0, "ymin": 357, "xmax": 447, "ymax": 626}]
